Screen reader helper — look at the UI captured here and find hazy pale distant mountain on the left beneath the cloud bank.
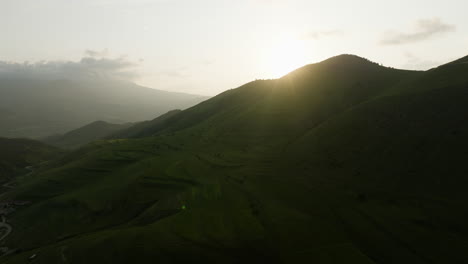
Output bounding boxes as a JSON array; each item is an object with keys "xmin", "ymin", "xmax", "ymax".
[{"xmin": 0, "ymin": 78, "xmax": 206, "ymax": 138}]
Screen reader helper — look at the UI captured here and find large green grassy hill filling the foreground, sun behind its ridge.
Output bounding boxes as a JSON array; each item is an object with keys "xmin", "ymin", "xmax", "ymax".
[{"xmin": 1, "ymin": 55, "xmax": 468, "ymax": 264}]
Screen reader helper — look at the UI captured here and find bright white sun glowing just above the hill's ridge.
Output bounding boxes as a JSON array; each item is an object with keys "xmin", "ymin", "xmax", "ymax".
[{"xmin": 263, "ymin": 38, "xmax": 307, "ymax": 78}]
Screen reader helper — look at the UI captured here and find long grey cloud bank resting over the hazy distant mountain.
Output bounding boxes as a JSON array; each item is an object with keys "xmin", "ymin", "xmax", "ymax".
[{"xmin": 0, "ymin": 50, "xmax": 139, "ymax": 81}]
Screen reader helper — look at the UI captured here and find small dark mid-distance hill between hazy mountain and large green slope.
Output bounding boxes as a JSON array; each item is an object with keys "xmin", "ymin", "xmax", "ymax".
[{"xmin": 42, "ymin": 121, "xmax": 133, "ymax": 149}]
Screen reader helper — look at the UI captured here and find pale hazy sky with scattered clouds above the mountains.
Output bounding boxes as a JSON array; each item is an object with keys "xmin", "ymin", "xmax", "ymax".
[{"xmin": 0, "ymin": 0, "xmax": 468, "ymax": 95}]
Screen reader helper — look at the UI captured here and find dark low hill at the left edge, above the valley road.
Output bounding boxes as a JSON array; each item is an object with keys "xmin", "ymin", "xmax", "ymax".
[{"xmin": 0, "ymin": 138, "xmax": 60, "ymax": 184}]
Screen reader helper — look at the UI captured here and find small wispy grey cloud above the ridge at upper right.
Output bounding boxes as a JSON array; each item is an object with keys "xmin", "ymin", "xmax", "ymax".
[{"xmin": 380, "ymin": 18, "xmax": 456, "ymax": 45}]
